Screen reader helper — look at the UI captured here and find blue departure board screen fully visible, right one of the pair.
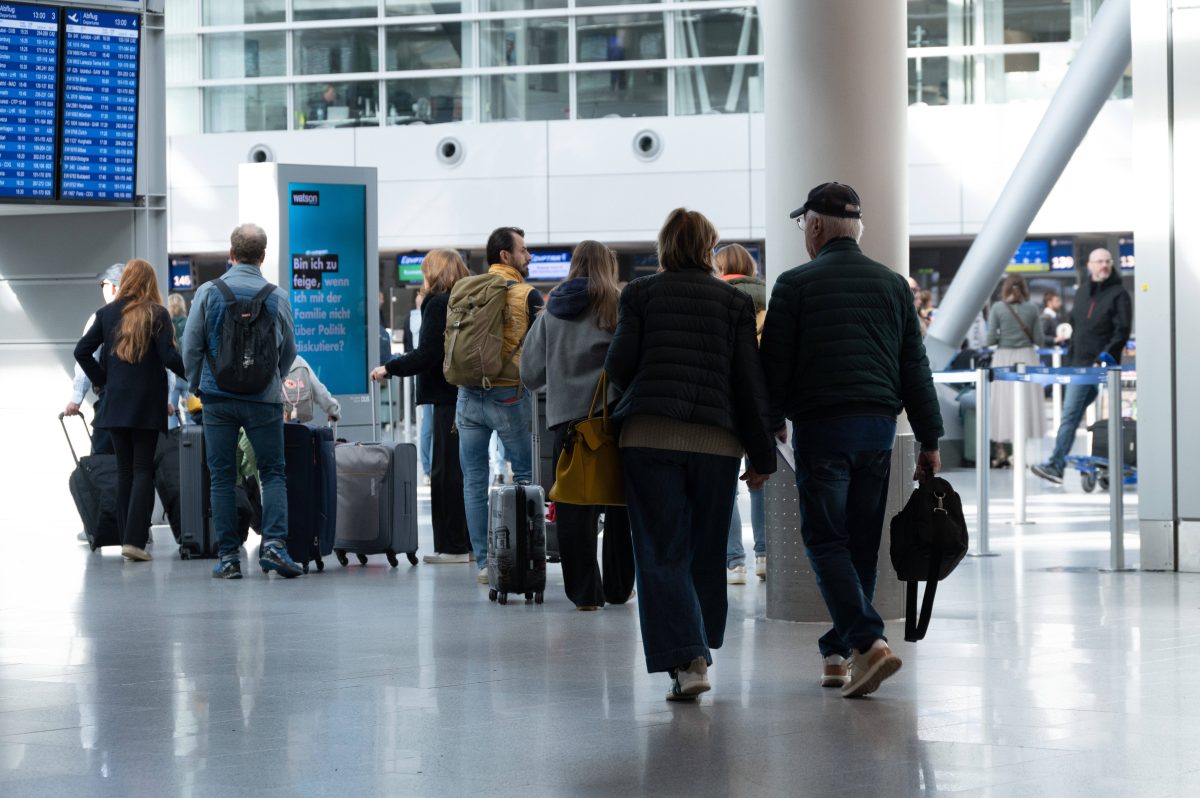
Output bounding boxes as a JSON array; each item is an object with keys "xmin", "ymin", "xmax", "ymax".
[{"xmin": 59, "ymin": 8, "xmax": 139, "ymax": 202}]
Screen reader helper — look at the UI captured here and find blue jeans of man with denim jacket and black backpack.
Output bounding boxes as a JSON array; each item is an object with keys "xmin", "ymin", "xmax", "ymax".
[{"xmin": 204, "ymin": 396, "xmax": 288, "ymax": 559}]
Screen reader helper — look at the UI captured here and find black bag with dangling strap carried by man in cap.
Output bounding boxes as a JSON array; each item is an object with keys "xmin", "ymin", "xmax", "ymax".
[{"xmin": 892, "ymin": 476, "xmax": 967, "ymax": 642}]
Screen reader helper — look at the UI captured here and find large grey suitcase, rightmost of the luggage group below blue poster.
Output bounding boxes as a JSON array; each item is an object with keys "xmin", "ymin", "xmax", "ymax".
[{"xmin": 334, "ymin": 443, "xmax": 416, "ymax": 568}]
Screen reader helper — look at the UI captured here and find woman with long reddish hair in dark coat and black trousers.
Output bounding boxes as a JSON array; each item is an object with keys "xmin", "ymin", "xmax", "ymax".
[{"xmin": 74, "ymin": 259, "xmax": 184, "ymax": 562}]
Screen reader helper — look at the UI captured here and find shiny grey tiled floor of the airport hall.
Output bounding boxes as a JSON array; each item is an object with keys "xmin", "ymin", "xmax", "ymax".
[{"xmin": 0, "ymin": 474, "xmax": 1200, "ymax": 798}]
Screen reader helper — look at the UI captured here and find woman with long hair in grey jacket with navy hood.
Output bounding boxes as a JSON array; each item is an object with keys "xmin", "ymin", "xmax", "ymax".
[{"xmin": 521, "ymin": 241, "xmax": 634, "ymax": 610}]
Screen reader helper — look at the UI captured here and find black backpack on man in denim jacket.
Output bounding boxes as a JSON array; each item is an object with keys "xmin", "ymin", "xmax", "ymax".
[{"xmin": 205, "ymin": 278, "xmax": 280, "ymax": 394}]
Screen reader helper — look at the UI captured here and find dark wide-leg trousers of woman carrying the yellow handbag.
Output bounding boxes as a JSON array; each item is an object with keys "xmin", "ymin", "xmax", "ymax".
[{"xmin": 619, "ymin": 448, "xmax": 739, "ymax": 673}]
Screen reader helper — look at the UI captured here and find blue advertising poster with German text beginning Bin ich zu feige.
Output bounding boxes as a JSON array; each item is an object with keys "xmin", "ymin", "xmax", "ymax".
[{"xmin": 288, "ymin": 182, "xmax": 374, "ymax": 394}]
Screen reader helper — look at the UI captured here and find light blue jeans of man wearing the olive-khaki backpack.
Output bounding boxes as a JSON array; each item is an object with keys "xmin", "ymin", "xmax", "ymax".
[{"xmin": 455, "ymin": 385, "xmax": 533, "ymax": 568}]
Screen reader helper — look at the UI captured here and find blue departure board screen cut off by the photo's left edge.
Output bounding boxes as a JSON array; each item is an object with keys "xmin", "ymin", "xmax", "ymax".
[{"xmin": 0, "ymin": 2, "xmax": 60, "ymax": 199}]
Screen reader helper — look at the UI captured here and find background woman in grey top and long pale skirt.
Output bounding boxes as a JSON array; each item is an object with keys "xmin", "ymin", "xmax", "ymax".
[{"xmin": 988, "ymin": 275, "xmax": 1045, "ymax": 468}]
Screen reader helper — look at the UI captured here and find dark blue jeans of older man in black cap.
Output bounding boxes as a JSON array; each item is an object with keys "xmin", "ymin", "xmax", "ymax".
[{"xmin": 793, "ymin": 416, "xmax": 895, "ymax": 656}]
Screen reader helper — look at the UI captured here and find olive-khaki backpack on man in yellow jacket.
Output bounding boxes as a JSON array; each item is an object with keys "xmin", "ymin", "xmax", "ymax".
[{"xmin": 442, "ymin": 274, "xmax": 524, "ymax": 388}]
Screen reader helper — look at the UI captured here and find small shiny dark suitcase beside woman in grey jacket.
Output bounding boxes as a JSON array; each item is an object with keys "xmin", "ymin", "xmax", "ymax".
[{"xmin": 487, "ymin": 485, "xmax": 546, "ymax": 604}]
